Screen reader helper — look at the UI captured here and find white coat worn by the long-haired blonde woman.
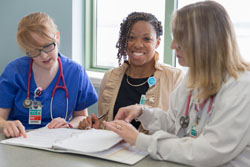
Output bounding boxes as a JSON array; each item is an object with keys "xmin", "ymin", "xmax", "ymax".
[{"xmin": 136, "ymin": 72, "xmax": 250, "ymax": 167}]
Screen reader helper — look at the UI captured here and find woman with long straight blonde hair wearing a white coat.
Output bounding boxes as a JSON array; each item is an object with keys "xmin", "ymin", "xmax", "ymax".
[{"xmin": 104, "ymin": 1, "xmax": 250, "ymax": 167}]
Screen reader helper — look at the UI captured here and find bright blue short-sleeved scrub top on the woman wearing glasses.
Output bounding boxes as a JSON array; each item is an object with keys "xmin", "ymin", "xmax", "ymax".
[{"xmin": 0, "ymin": 53, "xmax": 97, "ymax": 129}]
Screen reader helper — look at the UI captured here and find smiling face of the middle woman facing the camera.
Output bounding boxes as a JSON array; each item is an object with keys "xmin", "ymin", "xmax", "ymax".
[{"xmin": 127, "ymin": 21, "xmax": 160, "ymax": 66}]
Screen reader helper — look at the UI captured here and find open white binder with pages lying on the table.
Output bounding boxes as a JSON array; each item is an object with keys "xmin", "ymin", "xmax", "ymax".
[{"xmin": 0, "ymin": 127, "xmax": 148, "ymax": 165}]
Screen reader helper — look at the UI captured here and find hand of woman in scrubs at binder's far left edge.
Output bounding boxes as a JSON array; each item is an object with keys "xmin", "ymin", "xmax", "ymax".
[{"xmin": 3, "ymin": 120, "xmax": 27, "ymax": 138}]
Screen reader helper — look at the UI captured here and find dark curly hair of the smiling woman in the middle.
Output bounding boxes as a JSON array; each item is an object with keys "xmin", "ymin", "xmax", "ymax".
[{"xmin": 116, "ymin": 12, "xmax": 163, "ymax": 65}]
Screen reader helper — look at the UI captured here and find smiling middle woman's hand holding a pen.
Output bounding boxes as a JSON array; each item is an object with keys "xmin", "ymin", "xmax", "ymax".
[{"xmin": 78, "ymin": 113, "xmax": 100, "ymax": 129}]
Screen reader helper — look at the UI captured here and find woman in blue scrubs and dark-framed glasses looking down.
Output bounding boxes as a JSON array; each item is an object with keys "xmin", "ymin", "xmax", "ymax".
[{"xmin": 0, "ymin": 12, "xmax": 97, "ymax": 137}]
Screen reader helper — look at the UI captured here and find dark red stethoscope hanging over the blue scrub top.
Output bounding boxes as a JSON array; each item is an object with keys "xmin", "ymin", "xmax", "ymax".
[{"xmin": 23, "ymin": 57, "xmax": 69, "ymax": 120}]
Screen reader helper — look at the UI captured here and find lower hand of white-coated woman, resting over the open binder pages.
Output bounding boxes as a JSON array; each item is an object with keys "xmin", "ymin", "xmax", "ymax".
[{"xmin": 103, "ymin": 120, "xmax": 139, "ymax": 146}]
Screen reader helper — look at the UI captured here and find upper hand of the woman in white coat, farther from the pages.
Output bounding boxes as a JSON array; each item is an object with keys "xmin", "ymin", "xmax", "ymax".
[{"xmin": 115, "ymin": 104, "xmax": 142, "ymax": 123}]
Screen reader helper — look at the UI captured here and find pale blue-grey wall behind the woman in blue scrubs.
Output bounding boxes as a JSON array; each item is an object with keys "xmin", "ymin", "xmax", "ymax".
[{"xmin": 0, "ymin": 0, "xmax": 72, "ymax": 73}]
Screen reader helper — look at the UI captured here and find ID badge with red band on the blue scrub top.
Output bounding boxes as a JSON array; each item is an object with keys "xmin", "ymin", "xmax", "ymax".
[{"xmin": 29, "ymin": 101, "xmax": 42, "ymax": 124}]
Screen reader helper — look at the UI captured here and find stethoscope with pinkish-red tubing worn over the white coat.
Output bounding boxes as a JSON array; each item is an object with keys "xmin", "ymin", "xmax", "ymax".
[{"xmin": 180, "ymin": 91, "xmax": 214, "ymax": 128}]
